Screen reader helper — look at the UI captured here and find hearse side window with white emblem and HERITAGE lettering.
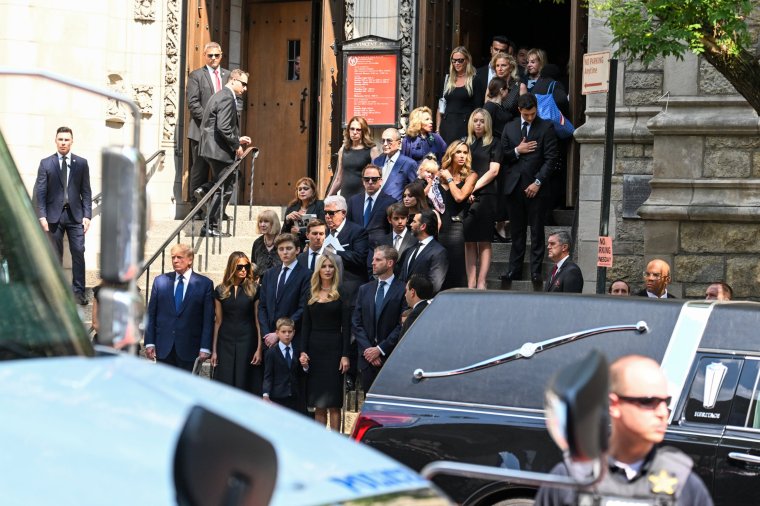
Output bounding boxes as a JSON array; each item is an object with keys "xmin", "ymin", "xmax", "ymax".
[{"xmin": 681, "ymin": 357, "xmax": 743, "ymax": 425}]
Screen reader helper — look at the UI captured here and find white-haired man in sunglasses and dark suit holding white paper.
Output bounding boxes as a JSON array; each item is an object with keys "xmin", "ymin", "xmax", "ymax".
[{"xmin": 325, "ymin": 195, "xmax": 369, "ymax": 307}]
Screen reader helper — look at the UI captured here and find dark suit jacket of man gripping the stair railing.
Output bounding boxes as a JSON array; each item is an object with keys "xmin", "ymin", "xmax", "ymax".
[{"xmin": 199, "ymin": 87, "xmax": 240, "ymax": 163}]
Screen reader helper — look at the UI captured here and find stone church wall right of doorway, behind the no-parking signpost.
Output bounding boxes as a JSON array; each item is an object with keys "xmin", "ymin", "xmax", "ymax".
[{"xmin": 576, "ymin": 8, "xmax": 760, "ymax": 300}]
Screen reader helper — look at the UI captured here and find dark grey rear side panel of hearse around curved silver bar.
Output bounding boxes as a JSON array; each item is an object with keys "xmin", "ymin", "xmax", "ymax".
[{"xmin": 378, "ymin": 291, "xmax": 683, "ymax": 409}]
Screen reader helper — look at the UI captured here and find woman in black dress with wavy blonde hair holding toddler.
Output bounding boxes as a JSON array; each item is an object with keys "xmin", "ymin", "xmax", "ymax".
[{"xmin": 433, "ymin": 141, "xmax": 478, "ymax": 290}]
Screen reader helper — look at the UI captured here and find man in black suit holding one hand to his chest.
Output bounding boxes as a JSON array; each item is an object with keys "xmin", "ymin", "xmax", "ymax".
[{"xmin": 501, "ymin": 93, "xmax": 558, "ymax": 283}]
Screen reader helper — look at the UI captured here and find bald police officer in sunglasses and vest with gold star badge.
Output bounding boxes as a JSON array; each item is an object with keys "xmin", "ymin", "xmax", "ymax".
[{"xmin": 535, "ymin": 355, "xmax": 713, "ymax": 506}]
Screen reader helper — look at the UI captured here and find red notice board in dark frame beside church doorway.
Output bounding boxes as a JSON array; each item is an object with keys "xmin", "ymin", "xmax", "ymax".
[{"xmin": 342, "ymin": 36, "xmax": 401, "ymax": 127}]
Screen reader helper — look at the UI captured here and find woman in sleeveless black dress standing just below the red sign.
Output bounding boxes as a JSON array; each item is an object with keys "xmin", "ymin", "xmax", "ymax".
[{"xmin": 327, "ymin": 116, "xmax": 380, "ymax": 201}]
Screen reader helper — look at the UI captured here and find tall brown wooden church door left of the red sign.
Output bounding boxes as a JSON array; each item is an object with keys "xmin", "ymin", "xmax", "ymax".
[{"xmin": 244, "ymin": 2, "xmax": 312, "ymax": 205}]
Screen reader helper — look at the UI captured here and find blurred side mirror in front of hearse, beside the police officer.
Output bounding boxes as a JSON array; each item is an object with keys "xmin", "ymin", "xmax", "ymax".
[{"xmin": 544, "ymin": 350, "xmax": 609, "ymax": 462}]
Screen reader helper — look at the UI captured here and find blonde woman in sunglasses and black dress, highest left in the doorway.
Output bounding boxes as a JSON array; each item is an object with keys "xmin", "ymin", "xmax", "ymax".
[{"xmin": 436, "ymin": 46, "xmax": 486, "ymax": 144}]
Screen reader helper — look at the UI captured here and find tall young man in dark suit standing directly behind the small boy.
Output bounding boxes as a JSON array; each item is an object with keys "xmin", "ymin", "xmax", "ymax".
[{"xmin": 258, "ymin": 234, "xmax": 311, "ymax": 348}]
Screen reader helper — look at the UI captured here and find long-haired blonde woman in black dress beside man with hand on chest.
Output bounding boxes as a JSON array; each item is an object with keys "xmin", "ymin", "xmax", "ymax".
[{"xmin": 464, "ymin": 109, "xmax": 501, "ymax": 290}]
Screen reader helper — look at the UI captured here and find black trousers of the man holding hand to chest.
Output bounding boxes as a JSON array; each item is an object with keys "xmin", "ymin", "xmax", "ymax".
[{"xmin": 507, "ymin": 186, "xmax": 546, "ymax": 276}]
